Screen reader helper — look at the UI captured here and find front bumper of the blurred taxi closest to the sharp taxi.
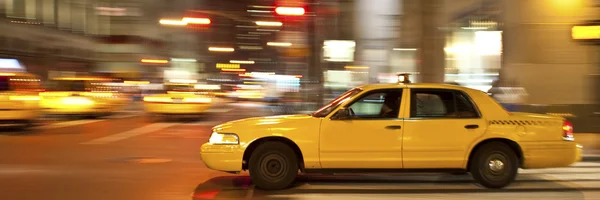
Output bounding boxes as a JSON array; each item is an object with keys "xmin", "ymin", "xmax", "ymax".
[{"xmin": 144, "ymin": 102, "xmax": 211, "ymax": 114}]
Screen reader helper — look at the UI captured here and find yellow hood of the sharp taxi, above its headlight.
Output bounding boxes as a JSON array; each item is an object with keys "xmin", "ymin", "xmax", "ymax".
[{"xmin": 213, "ymin": 114, "xmax": 316, "ymax": 132}]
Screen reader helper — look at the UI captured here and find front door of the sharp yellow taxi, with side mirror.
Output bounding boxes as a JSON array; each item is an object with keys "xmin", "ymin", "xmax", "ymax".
[{"xmin": 319, "ymin": 88, "xmax": 408, "ymax": 169}]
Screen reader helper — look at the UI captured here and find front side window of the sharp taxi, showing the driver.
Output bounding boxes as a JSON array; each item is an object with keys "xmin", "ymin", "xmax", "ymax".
[{"xmin": 348, "ymin": 90, "xmax": 402, "ymax": 119}]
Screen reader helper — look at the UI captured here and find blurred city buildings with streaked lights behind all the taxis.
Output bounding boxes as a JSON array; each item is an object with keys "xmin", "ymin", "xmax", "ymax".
[{"xmin": 0, "ymin": 0, "xmax": 600, "ymax": 132}]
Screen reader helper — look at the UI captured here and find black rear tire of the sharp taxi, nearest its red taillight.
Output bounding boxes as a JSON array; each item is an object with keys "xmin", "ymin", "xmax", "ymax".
[{"xmin": 469, "ymin": 142, "xmax": 519, "ymax": 189}]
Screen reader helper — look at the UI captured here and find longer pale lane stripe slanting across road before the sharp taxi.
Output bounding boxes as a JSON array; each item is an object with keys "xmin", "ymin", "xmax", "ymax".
[{"xmin": 80, "ymin": 123, "xmax": 181, "ymax": 144}]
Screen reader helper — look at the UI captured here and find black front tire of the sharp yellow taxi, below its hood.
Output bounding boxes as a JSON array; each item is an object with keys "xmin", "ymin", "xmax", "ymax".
[{"xmin": 248, "ymin": 142, "xmax": 298, "ymax": 190}]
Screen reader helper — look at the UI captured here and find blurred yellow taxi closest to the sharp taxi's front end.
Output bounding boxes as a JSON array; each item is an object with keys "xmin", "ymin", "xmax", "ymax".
[{"xmin": 144, "ymin": 83, "xmax": 214, "ymax": 115}]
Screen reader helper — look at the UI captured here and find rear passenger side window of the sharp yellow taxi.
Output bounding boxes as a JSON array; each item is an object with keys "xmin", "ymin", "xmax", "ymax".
[{"xmin": 410, "ymin": 89, "xmax": 480, "ymax": 118}]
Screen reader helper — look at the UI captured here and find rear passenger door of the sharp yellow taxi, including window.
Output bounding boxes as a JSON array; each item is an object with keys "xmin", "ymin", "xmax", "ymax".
[{"xmin": 402, "ymin": 89, "xmax": 487, "ymax": 168}]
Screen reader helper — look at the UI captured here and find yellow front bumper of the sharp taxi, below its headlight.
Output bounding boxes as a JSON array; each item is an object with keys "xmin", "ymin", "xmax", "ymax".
[{"xmin": 200, "ymin": 143, "xmax": 244, "ymax": 172}]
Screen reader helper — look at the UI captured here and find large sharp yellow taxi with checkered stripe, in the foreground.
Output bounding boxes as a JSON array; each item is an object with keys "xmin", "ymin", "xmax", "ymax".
[{"xmin": 201, "ymin": 74, "xmax": 581, "ymax": 189}]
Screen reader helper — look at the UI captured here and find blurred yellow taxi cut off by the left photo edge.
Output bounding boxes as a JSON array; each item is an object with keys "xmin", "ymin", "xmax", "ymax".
[{"xmin": 0, "ymin": 72, "xmax": 41, "ymax": 127}]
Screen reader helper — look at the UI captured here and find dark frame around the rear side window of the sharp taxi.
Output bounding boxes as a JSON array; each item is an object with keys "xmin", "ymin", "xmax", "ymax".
[{"xmin": 406, "ymin": 88, "xmax": 483, "ymax": 119}]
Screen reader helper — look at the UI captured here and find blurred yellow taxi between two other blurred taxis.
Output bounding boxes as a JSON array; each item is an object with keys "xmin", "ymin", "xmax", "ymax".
[{"xmin": 40, "ymin": 76, "xmax": 129, "ymax": 117}]
